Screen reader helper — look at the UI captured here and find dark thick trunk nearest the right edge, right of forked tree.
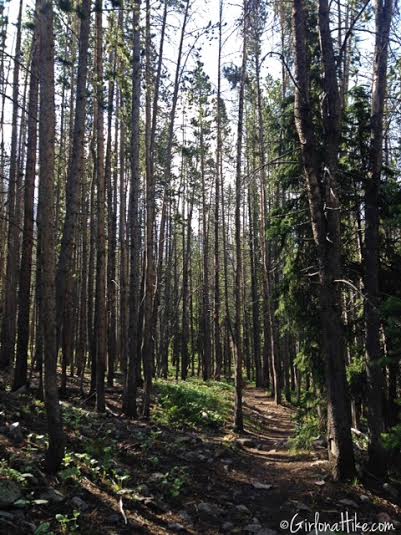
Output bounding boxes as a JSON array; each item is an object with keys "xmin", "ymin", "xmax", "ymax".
[{"xmin": 364, "ymin": 0, "xmax": 393, "ymax": 475}]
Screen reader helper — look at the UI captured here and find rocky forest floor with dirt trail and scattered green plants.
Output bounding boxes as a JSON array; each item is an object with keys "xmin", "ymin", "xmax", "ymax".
[{"xmin": 0, "ymin": 380, "xmax": 401, "ymax": 535}]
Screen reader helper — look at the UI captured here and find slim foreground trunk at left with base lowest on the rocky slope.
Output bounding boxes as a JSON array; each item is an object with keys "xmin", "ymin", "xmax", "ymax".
[{"xmin": 39, "ymin": 0, "xmax": 65, "ymax": 472}]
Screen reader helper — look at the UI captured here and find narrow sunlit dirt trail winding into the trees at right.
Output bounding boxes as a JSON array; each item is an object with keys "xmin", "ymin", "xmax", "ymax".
[{"xmin": 211, "ymin": 389, "xmax": 401, "ymax": 535}]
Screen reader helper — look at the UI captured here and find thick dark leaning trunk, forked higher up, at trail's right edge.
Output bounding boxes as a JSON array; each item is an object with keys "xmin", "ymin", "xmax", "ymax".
[{"xmin": 293, "ymin": 0, "xmax": 355, "ymax": 479}]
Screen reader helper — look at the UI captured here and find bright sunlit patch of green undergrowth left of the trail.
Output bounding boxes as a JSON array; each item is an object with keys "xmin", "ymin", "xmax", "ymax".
[{"xmin": 154, "ymin": 379, "xmax": 234, "ymax": 430}]
